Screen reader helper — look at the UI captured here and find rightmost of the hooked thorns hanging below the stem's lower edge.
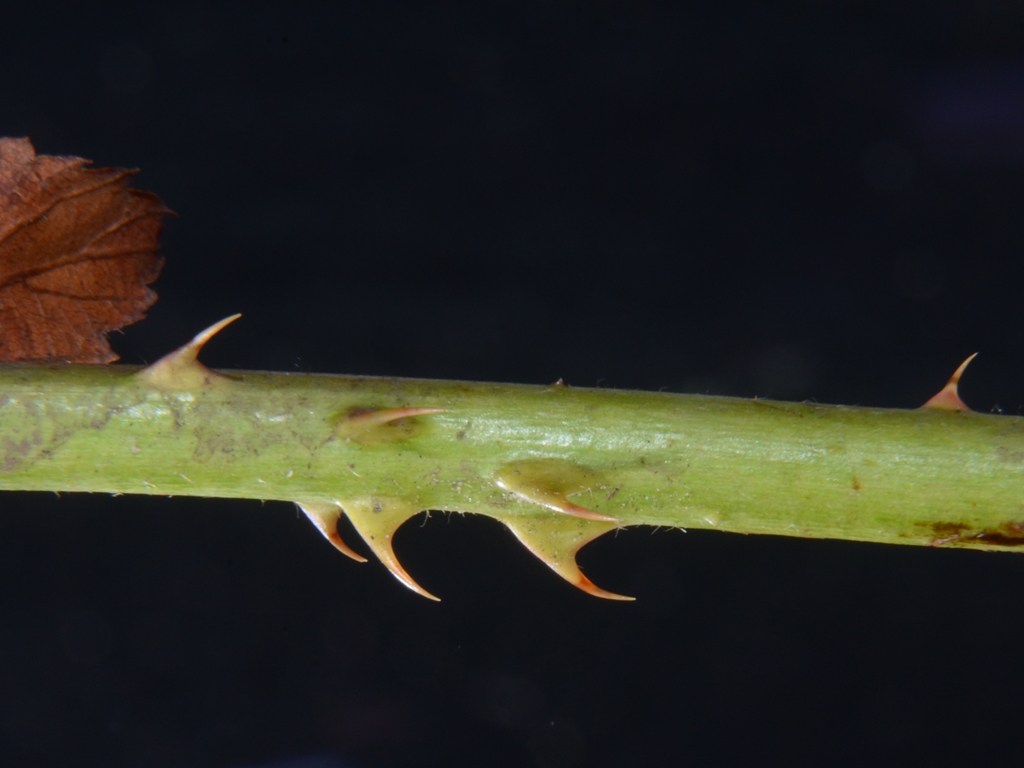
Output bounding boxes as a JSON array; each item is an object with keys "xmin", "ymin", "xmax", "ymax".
[{"xmin": 502, "ymin": 516, "xmax": 636, "ymax": 600}]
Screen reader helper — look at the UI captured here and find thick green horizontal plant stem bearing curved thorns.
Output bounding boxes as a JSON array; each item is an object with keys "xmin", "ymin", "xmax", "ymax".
[{"xmin": 0, "ymin": 354, "xmax": 1024, "ymax": 602}]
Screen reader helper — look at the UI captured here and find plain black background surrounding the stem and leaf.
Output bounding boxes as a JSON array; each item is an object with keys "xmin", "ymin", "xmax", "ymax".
[{"xmin": 0, "ymin": 0, "xmax": 1024, "ymax": 768}]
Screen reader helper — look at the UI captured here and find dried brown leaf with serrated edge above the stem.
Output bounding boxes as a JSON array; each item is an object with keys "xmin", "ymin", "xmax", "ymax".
[{"xmin": 0, "ymin": 137, "xmax": 170, "ymax": 362}]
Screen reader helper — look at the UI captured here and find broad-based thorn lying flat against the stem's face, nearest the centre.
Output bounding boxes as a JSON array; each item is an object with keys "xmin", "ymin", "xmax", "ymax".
[{"xmin": 495, "ymin": 459, "xmax": 618, "ymax": 522}]
